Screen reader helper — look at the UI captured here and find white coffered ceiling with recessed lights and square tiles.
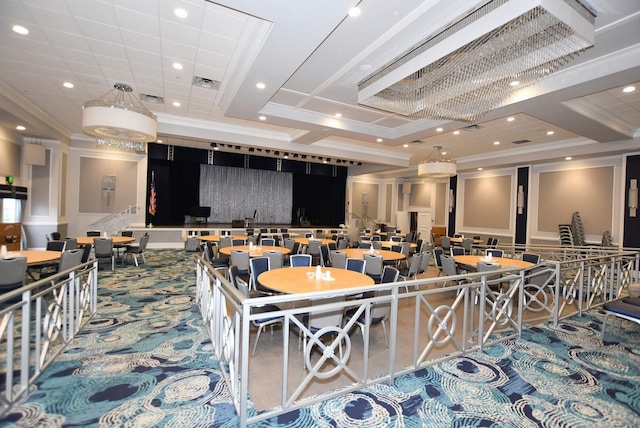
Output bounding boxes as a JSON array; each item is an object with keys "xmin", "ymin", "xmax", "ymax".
[{"xmin": 0, "ymin": 0, "xmax": 640, "ymax": 178}]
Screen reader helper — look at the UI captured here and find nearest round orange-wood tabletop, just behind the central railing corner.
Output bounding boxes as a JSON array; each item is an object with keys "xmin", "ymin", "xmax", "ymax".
[{"xmin": 258, "ymin": 266, "xmax": 375, "ymax": 293}]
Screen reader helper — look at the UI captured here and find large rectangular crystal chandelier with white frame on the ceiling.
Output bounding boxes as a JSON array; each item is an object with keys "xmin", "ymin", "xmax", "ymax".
[{"xmin": 358, "ymin": 0, "xmax": 595, "ymax": 122}]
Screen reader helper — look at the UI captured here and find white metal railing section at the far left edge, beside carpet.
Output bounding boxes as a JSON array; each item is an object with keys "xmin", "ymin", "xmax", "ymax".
[{"xmin": 0, "ymin": 261, "xmax": 98, "ymax": 415}]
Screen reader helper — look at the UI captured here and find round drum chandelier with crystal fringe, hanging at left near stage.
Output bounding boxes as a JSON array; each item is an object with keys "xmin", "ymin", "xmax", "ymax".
[{"xmin": 82, "ymin": 83, "xmax": 158, "ymax": 151}]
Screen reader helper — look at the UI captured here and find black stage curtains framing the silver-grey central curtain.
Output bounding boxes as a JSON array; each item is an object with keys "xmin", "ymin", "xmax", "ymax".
[{"xmin": 145, "ymin": 143, "xmax": 347, "ymax": 227}]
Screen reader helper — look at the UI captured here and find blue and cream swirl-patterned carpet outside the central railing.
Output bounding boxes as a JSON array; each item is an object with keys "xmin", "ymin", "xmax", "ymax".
[{"xmin": 0, "ymin": 250, "xmax": 640, "ymax": 428}]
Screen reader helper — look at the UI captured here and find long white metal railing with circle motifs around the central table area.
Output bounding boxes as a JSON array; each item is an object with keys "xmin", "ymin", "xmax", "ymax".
[{"xmin": 195, "ymin": 248, "xmax": 639, "ymax": 426}]
